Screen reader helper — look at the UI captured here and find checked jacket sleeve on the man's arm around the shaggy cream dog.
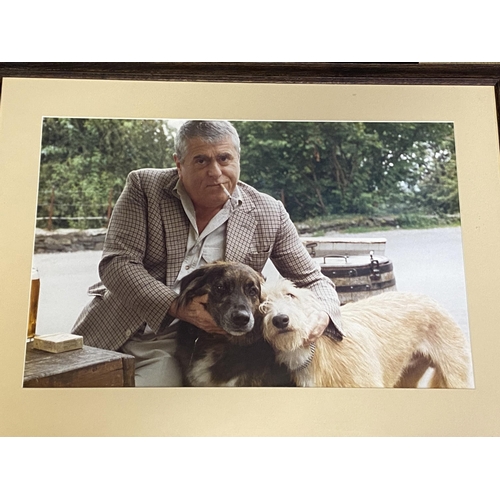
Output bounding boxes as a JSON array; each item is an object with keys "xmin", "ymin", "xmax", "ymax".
[{"xmin": 271, "ymin": 202, "xmax": 343, "ymax": 339}]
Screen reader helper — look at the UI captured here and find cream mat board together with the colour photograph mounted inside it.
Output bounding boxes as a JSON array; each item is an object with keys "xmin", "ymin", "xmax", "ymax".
[{"xmin": 0, "ymin": 78, "xmax": 500, "ymax": 437}]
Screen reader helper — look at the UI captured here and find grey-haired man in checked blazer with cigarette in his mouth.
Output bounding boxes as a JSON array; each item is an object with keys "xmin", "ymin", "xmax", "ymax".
[{"xmin": 73, "ymin": 121, "xmax": 342, "ymax": 386}]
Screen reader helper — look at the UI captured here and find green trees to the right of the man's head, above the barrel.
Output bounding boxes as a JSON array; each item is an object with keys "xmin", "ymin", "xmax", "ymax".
[{"xmin": 234, "ymin": 122, "xmax": 458, "ymax": 221}]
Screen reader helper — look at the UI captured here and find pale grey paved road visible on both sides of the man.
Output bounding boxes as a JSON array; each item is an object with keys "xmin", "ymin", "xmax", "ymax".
[{"xmin": 34, "ymin": 228, "xmax": 469, "ymax": 335}]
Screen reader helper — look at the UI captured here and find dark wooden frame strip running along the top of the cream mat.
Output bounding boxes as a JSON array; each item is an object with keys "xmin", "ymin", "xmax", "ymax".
[{"xmin": 0, "ymin": 62, "xmax": 500, "ymax": 85}]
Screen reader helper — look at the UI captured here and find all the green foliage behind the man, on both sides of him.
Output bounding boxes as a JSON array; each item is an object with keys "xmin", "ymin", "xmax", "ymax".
[{"xmin": 38, "ymin": 118, "xmax": 459, "ymax": 227}]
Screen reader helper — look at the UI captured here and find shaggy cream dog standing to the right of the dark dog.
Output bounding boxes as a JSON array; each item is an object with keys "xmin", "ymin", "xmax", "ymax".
[{"xmin": 261, "ymin": 280, "xmax": 473, "ymax": 388}]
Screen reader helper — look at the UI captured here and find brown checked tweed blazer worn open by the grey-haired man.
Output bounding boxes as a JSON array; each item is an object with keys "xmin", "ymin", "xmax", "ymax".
[{"xmin": 72, "ymin": 168, "xmax": 342, "ymax": 350}]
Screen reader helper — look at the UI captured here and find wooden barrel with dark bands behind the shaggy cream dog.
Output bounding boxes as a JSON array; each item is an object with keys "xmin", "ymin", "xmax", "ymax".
[{"xmin": 317, "ymin": 253, "xmax": 396, "ymax": 305}]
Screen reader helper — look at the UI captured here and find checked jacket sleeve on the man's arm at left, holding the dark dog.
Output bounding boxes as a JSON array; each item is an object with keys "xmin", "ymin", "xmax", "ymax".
[{"xmin": 99, "ymin": 171, "xmax": 177, "ymax": 331}]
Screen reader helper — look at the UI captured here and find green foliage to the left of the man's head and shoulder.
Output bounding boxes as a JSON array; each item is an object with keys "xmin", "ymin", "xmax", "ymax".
[{"xmin": 38, "ymin": 118, "xmax": 173, "ymax": 227}]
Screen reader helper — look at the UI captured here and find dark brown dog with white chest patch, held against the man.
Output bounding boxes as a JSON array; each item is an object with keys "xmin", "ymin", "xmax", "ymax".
[{"xmin": 176, "ymin": 262, "xmax": 293, "ymax": 387}]
